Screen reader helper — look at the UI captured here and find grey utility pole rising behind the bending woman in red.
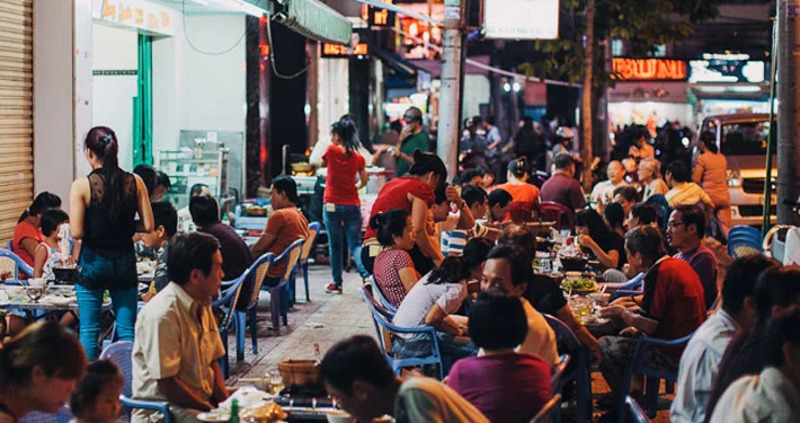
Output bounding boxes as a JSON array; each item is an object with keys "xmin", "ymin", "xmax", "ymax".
[{"xmin": 436, "ymin": 0, "xmax": 464, "ymax": 180}]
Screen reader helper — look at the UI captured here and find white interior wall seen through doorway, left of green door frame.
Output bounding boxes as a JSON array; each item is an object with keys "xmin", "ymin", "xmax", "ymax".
[{"xmin": 92, "ymin": 22, "xmax": 139, "ymax": 171}]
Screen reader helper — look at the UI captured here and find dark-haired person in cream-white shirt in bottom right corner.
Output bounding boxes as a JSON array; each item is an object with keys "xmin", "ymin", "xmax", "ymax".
[{"xmin": 709, "ymin": 306, "xmax": 800, "ymax": 423}]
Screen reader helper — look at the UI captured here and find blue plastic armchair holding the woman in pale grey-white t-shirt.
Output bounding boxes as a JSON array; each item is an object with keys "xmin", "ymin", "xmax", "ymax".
[{"xmin": 361, "ymin": 286, "xmax": 444, "ymax": 380}]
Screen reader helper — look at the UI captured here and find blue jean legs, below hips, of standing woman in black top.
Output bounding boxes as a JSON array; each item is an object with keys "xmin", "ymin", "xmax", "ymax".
[{"xmin": 75, "ymin": 284, "xmax": 139, "ymax": 360}]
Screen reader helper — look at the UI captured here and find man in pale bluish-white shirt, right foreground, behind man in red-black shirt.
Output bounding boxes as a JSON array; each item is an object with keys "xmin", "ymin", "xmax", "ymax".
[{"xmin": 670, "ymin": 255, "xmax": 774, "ymax": 423}]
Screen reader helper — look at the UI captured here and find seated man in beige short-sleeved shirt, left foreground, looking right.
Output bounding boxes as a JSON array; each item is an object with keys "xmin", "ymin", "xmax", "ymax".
[{"xmin": 132, "ymin": 232, "xmax": 228, "ymax": 423}]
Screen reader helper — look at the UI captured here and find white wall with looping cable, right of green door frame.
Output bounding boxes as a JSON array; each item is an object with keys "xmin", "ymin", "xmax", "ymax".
[{"xmin": 153, "ymin": 15, "xmax": 246, "ymax": 157}]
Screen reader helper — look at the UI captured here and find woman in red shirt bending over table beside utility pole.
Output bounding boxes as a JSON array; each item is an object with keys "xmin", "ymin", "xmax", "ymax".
[{"xmin": 361, "ymin": 150, "xmax": 447, "ymax": 275}]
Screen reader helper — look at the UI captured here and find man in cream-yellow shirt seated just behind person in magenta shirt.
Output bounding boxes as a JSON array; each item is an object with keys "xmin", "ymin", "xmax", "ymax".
[{"xmin": 481, "ymin": 245, "xmax": 558, "ymax": 365}]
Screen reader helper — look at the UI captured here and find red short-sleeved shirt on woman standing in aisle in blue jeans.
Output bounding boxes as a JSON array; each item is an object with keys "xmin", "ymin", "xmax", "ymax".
[{"xmin": 322, "ymin": 145, "xmax": 366, "ymax": 206}]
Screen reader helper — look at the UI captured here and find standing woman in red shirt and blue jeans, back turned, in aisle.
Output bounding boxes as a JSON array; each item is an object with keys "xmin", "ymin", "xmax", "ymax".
[{"xmin": 322, "ymin": 116, "xmax": 369, "ymax": 294}]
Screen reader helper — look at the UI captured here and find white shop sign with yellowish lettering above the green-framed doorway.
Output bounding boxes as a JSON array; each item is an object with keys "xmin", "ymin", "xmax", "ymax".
[{"xmin": 92, "ymin": 0, "xmax": 179, "ymax": 36}]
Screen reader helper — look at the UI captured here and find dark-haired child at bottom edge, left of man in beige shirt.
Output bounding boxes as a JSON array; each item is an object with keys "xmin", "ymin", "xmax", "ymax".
[{"xmin": 69, "ymin": 360, "xmax": 124, "ymax": 423}]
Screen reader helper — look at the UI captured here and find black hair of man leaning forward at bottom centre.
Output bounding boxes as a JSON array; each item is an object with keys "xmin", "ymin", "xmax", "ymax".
[{"xmin": 319, "ymin": 335, "xmax": 395, "ymax": 395}]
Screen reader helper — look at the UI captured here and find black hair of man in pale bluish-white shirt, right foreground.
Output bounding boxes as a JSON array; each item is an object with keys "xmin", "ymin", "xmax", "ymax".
[{"xmin": 722, "ymin": 254, "xmax": 780, "ymax": 316}]
